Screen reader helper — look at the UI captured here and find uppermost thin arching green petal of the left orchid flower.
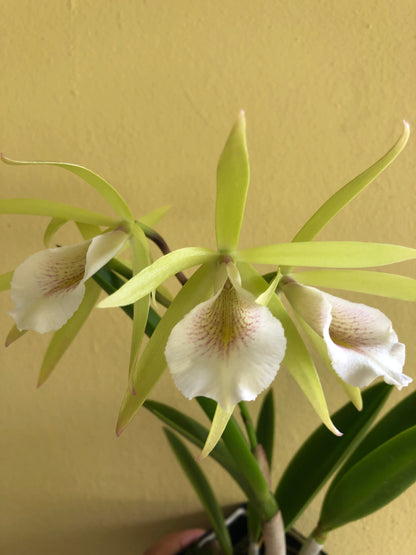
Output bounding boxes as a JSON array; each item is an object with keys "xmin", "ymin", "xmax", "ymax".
[{"xmin": 1, "ymin": 155, "xmax": 133, "ymax": 221}]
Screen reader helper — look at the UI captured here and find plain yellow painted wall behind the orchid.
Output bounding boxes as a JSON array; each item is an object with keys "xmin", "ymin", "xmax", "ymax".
[{"xmin": 0, "ymin": 0, "xmax": 416, "ymax": 555}]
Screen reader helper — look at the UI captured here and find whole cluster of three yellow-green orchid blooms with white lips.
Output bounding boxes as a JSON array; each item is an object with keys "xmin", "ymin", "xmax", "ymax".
[{"xmin": 0, "ymin": 112, "xmax": 416, "ymax": 552}]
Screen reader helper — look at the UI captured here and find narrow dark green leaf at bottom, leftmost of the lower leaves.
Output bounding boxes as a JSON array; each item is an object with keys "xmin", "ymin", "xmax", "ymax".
[{"xmin": 165, "ymin": 429, "xmax": 233, "ymax": 555}]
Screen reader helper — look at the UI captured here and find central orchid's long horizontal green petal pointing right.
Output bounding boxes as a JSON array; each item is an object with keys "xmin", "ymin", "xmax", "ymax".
[{"xmin": 236, "ymin": 241, "xmax": 416, "ymax": 268}]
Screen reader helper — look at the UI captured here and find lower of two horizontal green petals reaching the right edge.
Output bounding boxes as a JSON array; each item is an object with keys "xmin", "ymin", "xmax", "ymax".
[{"xmin": 291, "ymin": 270, "xmax": 416, "ymax": 301}]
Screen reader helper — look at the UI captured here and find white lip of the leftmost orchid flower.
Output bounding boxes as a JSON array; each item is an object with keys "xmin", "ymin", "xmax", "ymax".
[{"xmin": 9, "ymin": 230, "xmax": 128, "ymax": 333}]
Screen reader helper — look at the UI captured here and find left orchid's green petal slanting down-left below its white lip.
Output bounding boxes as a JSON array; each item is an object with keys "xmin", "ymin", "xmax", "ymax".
[{"xmin": 38, "ymin": 280, "xmax": 101, "ymax": 387}]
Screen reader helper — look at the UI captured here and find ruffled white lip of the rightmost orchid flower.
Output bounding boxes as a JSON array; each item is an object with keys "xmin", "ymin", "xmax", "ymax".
[{"xmin": 283, "ymin": 278, "xmax": 412, "ymax": 389}]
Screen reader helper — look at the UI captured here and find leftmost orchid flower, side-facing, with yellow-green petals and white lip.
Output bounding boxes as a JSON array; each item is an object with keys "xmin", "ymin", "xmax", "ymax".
[{"xmin": 0, "ymin": 156, "xmax": 166, "ymax": 384}]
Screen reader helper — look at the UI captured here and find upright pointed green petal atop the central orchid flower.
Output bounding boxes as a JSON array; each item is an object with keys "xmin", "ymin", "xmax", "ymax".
[{"xmin": 215, "ymin": 111, "xmax": 250, "ymax": 252}]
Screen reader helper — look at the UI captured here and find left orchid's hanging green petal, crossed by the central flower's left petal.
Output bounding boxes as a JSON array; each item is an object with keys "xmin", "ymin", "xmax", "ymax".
[{"xmin": 129, "ymin": 226, "xmax": 149, "ymax": 377}]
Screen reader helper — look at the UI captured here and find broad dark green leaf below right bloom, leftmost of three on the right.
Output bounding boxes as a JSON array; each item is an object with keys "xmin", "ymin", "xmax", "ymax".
[{"xmin": 276, "ymin": 383, "xmax": 392, "ymax": 529}]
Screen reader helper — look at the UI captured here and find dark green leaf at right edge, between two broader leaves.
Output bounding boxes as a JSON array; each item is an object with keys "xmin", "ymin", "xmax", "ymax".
[{"xmin": 331, "ymin": 391, "xmax": 416, "ymax": 487}]
